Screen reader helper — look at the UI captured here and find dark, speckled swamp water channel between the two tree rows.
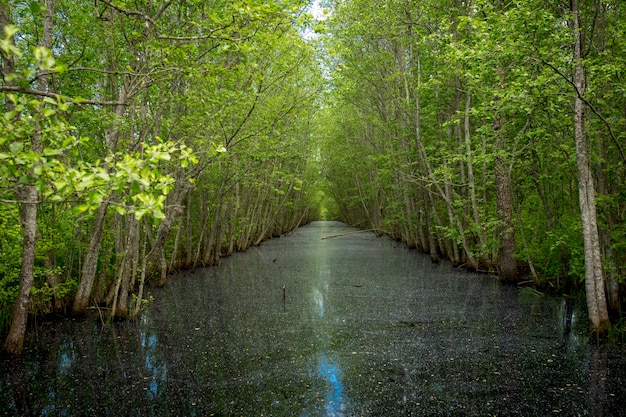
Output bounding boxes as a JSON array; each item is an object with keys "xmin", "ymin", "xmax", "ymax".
[{"xmin": 0, "ymin": 222, "xmax": 626, "ymax": 417}]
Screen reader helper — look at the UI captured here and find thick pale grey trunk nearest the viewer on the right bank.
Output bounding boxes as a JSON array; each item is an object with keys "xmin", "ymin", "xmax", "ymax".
[{"xmin": 570, "ymin": 0, "xmax": 611, "ymax": 334}]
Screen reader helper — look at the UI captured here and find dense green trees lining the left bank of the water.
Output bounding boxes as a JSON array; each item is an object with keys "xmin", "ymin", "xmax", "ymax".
[{"xmin": 0, "ymin": 0, "xmax": 320, "ymax": 353}]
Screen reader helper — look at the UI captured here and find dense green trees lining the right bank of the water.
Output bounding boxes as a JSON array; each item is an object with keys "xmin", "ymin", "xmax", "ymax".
[{"xmin": 323, "ymin": 0, "xmax": 626, "ymax": 331}]
